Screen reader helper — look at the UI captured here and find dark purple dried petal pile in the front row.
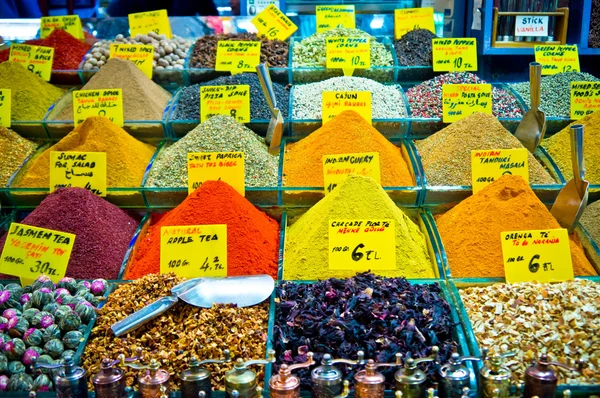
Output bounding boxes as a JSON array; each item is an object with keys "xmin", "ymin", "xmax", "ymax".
[{"xmin": 273, "ymin": 273, "xmax": 456, "ymax": 388}]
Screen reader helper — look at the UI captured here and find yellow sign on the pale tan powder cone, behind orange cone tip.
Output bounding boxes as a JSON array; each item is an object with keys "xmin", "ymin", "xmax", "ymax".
[{"xmin": 73, "ymin": 88, "xmax": 123, "ymax": 127}]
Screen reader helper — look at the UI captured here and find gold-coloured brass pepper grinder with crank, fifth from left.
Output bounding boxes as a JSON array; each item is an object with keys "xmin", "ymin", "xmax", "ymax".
[{"xmin": 225, "ymin": 350, "xmax": 275, "ymax": 398}]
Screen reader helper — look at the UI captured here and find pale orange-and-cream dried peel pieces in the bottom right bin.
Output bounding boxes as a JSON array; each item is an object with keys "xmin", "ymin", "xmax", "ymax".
[{"xmin": 459, "ymin": 279, "xmax": 600, "ymax": 385}]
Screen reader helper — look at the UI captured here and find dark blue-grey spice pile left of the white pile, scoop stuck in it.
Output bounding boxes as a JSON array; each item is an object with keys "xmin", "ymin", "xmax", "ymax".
[{"xmin": 173, "ymin": 73, "xmax": 290, "ymax": 120}]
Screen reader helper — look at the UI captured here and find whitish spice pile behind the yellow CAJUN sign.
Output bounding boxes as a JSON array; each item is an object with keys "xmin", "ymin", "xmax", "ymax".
[{"xmin": 292, "ymin": 76, "xmax": 406, "ymax": 119}]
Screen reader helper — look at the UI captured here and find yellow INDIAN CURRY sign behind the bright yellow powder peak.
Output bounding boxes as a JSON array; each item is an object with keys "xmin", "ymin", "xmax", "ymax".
[{"xmin": 323, "ymin": 152, "xmax": 381, "ymax": 194}]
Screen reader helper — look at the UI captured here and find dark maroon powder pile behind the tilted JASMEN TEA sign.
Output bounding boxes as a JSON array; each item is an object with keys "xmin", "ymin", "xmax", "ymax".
[{"xmin": 0, "ymin": 188, "xmax": 139, "ymax": 279}]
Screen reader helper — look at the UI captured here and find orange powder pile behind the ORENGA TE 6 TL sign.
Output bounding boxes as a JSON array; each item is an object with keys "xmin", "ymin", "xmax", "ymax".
[{"xmin": 436, "ymin": 175, "xmax": 596, "ymax": 278}]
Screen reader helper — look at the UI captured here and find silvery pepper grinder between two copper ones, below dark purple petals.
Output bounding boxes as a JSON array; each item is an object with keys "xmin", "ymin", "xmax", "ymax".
[{"xmin": 310, "ymin": 351, "xmax": 365, "ymax": 398}]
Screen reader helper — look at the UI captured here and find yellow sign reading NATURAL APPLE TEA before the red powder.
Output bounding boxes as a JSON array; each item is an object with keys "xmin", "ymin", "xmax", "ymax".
[{"xmin": 160, "ymin": 224, "xmax": 227, "ymax": 278}]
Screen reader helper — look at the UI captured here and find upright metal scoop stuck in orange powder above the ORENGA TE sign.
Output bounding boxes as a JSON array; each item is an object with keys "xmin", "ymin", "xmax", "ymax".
[{"xmin": 550, "ymin": 124, "xmax": 590, "ymax": 233}]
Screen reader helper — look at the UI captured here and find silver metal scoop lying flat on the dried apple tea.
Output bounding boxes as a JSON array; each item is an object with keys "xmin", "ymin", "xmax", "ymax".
[{"xmin": 111, "ymin": 275, "xmax": 275, "ymax": 336}]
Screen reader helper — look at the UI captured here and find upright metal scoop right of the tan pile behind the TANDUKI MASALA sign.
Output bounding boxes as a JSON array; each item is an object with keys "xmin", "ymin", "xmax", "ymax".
[{"xmin": 515, "ymin": 62, "xmax": 546, "ymax": 153}]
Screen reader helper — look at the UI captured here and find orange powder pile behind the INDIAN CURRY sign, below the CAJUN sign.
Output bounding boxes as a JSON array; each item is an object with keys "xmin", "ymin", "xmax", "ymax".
[{"xmin": 283, "ymin": 111, "xmax": 415, "ymax": 187}]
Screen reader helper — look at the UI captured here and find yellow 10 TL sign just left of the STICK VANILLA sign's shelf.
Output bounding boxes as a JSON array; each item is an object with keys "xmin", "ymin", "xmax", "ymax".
[{"xmin": 432, "ymin": 38, "xmax": 477, "ymax": 72}]
